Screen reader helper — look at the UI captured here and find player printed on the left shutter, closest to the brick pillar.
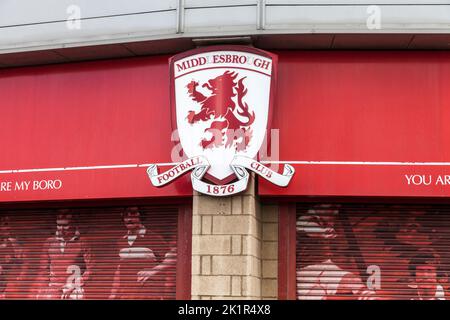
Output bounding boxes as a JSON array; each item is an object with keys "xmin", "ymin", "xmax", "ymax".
[{"xmin": 109, "ymin": 207, "xmax": 176, "ymax": 299}]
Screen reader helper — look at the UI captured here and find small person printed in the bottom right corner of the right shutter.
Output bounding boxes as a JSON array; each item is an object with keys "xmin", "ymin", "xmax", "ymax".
[{"xmin": 409, "ymin": 250, "xmax": 445, "ymax": 300}]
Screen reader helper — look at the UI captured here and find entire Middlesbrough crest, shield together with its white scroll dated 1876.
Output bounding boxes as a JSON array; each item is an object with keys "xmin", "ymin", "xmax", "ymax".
[{"xmin": 147, "ymin": 46, "xmax": 295, "ymax": 196}]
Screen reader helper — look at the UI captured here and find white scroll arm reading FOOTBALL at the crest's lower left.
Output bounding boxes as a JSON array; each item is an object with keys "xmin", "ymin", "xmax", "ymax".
[{"xmin": 147, "ymin": 156, "xmax": 209, "ymax": 187}]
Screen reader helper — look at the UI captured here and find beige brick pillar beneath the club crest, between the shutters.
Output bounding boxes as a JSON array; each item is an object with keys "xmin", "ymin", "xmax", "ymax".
[{"xmin": 192, "ymin": 177, "xmax": 278, "ymax": 299}]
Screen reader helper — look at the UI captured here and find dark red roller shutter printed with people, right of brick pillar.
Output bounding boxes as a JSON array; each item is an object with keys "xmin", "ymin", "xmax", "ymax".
[{"xmin": 295, "ymin": 204, "xmax": 450, "ymax": 300}]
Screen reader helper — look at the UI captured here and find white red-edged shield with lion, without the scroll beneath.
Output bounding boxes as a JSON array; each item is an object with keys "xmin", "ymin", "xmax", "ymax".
[{"xmin": 170, "ymin": 46, "xmax": 277, "ymax": 184}]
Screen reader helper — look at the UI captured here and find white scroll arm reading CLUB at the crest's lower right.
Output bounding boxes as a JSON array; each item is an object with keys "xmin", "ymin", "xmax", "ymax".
[{"xmin": 231, "ymin": 156, "xmax": 295, "ymax": 187}]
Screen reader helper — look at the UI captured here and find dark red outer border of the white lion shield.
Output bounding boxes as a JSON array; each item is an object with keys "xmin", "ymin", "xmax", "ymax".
[{"xmin": 169, "ymin": 45, "xmax": 278, "ymax": 185}]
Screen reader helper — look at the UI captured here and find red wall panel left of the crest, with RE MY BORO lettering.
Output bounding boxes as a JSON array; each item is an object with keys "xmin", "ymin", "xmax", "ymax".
[{"xmin": 0, "ymin": 56, "xmax": 192, "ymax": 201}]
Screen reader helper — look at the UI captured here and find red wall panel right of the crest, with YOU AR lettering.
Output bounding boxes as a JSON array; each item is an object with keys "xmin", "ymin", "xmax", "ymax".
[{"xmin": 259, "ymin": 51, "xmax": 450, "ymax": 197}]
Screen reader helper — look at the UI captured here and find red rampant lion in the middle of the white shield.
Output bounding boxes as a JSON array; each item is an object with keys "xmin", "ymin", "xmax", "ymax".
[{"xmin": 186, "ymin": 71, "xmax": 255, "ymax": 151}]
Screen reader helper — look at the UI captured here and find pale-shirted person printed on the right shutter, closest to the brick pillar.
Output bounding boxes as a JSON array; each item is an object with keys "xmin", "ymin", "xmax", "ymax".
[{"xmin": 297, "ymin": 205, "xmax": 374, "ymax": 300}]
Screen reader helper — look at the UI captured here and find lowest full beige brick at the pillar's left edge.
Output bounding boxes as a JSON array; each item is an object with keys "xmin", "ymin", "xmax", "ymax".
[{"xmin": 192, "ymin": 276, "xmax": 231, "ymax": 296}]
